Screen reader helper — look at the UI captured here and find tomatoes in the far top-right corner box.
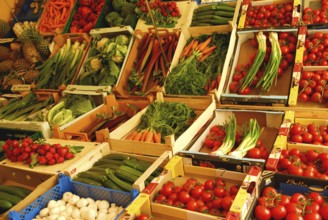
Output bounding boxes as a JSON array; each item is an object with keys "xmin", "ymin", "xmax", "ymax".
[{"xmin": 302, "ymin": 0, "xmax": 328, "ymax": 24}]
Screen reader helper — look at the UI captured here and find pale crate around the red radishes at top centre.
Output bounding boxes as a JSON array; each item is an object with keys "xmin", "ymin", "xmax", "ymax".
[{"xmin": 135, "ymin": 1, "xmax": 193, "ymax": 32}]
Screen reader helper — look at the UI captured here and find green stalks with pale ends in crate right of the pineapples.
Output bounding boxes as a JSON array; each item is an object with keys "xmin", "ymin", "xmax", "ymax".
[{"xmin": 35, "ymin": 38, "xmax": 86, "ymax": 90}]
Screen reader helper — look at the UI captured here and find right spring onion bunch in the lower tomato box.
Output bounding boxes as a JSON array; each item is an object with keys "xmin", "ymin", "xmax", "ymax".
[{"xmin": 230, "ymin": 118, "xmax": 263, "ymax": 158}]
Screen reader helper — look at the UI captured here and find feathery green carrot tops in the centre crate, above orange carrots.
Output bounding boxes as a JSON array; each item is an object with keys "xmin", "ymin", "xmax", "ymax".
[{"xmin": 138, "ymin": 101, "xmax": 196, "ymax": 142}]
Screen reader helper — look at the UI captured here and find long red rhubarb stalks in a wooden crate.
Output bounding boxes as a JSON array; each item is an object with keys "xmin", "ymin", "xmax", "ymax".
[{"xmin": 128, "ymin": 29, "xmax": 179, "ymax": 95}]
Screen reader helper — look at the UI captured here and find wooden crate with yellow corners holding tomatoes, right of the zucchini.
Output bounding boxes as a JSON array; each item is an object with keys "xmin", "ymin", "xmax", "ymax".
[{"xmin": 120, "ymin": 156, "xmax": 261, "ymax": 220}]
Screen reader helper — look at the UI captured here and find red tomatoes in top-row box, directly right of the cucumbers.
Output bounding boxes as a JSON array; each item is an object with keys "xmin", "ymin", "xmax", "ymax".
[{"xmin": 245, "ymin": 3, "xmax": 293, "ymax": 27}]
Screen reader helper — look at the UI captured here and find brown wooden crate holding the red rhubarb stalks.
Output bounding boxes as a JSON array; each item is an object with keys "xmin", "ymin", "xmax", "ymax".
[{"xmin": 113, "ymin": 28, "xmax": 181, "ymax": 97}]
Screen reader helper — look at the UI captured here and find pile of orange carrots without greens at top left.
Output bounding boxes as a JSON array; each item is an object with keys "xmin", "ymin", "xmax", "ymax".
[{"xmin": 38, "ymin": 0, "xmax": 75, "ymax": 32}]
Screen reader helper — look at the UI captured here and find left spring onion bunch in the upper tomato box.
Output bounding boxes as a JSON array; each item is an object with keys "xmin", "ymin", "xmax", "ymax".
[{"xmin": 240, "ymin": 31, "xmax": 266, "ymax": 91}]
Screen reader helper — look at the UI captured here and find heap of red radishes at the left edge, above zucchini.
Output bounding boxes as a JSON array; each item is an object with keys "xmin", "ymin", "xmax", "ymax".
[{"xmin": 2, "ymin": 138, "xmax": 84, "ymax": 168}]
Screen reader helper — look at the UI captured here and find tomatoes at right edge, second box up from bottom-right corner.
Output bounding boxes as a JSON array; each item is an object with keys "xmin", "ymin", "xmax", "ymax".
[{"xmin": 277, "ymin": 148, "xmax": 328, "ymax": 180}]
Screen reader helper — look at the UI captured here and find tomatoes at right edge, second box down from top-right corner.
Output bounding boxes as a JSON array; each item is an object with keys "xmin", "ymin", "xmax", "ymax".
[{"xmin": 303, "ymin": 31, "xmax": 328, "ymax": 66}]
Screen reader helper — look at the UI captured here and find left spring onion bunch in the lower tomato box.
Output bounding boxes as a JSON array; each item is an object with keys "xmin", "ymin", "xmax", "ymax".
[{"xmin": 211, "ymin": 115, "xmax": 237, "ymax": 156}]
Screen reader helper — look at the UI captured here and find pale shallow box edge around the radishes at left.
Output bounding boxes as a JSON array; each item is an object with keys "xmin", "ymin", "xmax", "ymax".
[{"xmin": 0, "ymin": 139, "xmax": 109, "ymax": 175}]
